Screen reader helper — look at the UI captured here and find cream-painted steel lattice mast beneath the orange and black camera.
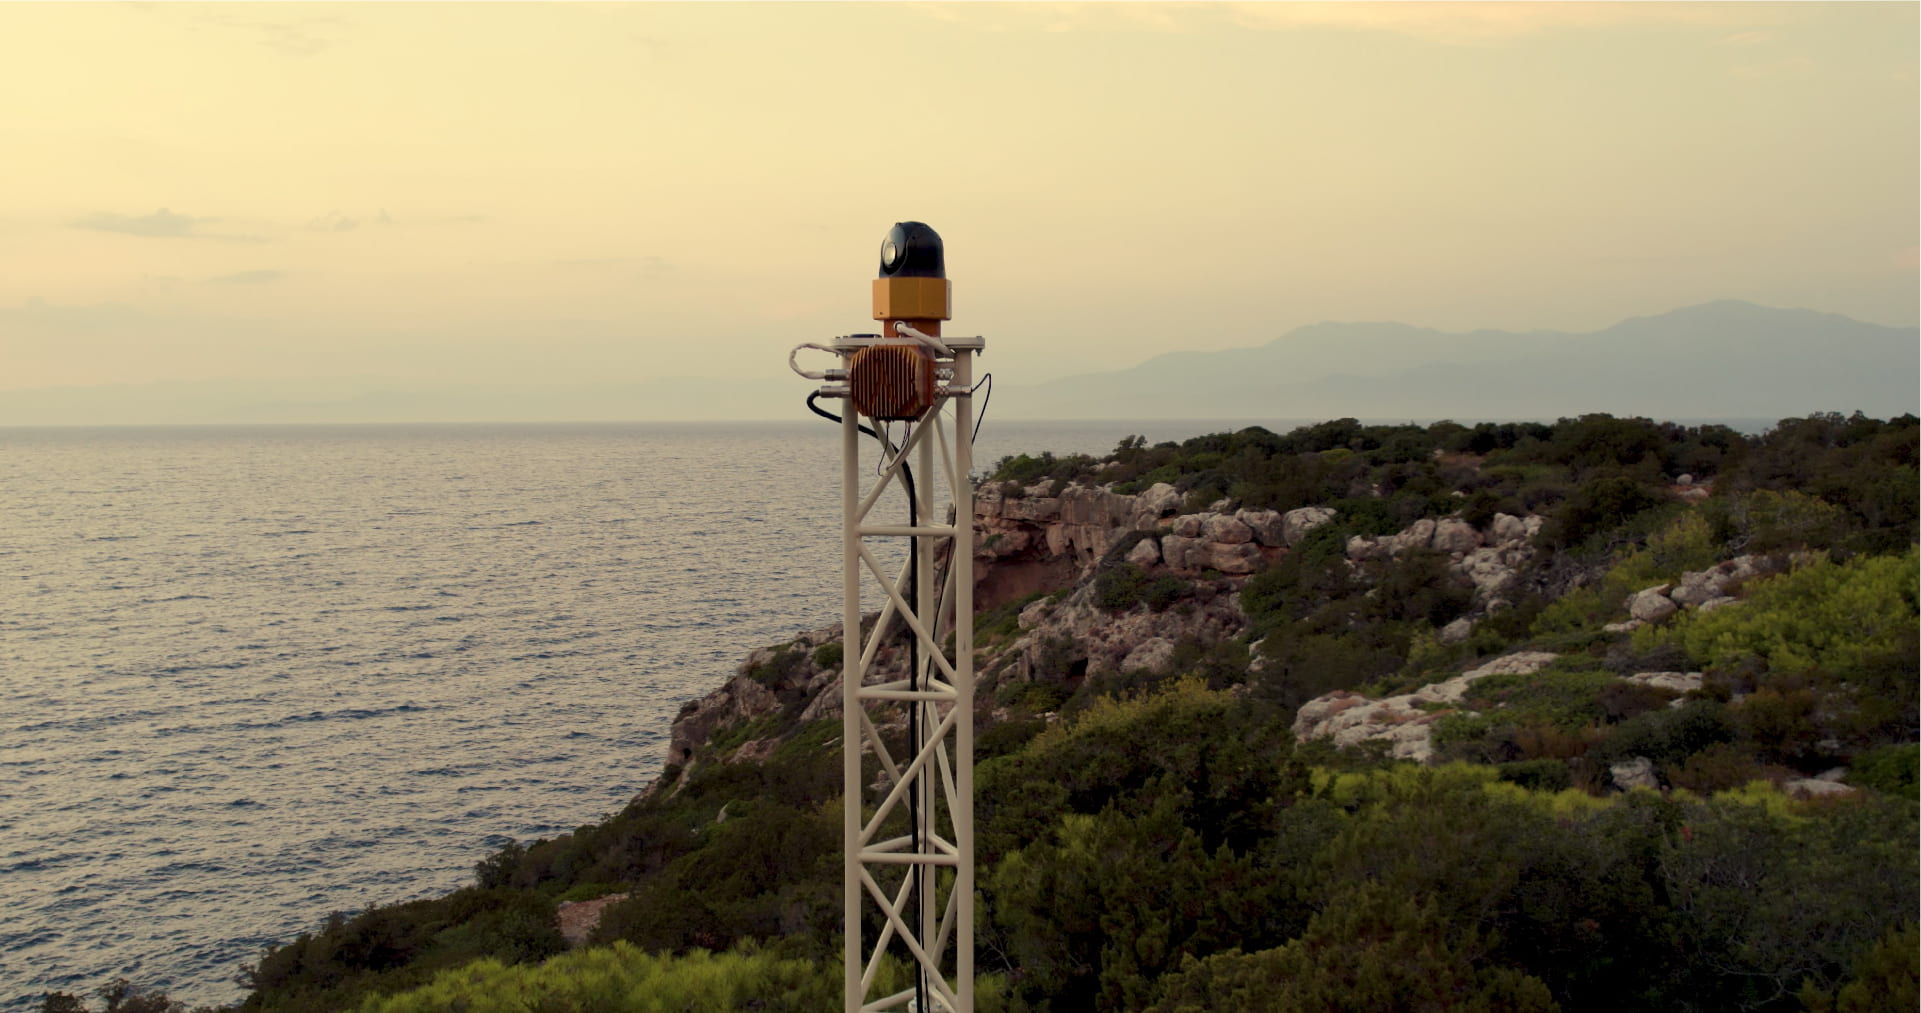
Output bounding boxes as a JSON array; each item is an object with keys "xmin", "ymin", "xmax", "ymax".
[{"xmin": 834, "ymin": 338, "xmax": 982, "ymax": 1013}]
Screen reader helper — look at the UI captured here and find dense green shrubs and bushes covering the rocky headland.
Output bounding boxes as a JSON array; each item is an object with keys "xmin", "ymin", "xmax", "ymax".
[{"xmin": 50, "ymin": 415, "xmax": 1921, "ymax": 1013}]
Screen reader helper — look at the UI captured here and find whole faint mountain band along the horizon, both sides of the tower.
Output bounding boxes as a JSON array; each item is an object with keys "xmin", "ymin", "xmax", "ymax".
[{"xmin": 0, "ymin": 302, "xmax": 1921, "ymax": 425}]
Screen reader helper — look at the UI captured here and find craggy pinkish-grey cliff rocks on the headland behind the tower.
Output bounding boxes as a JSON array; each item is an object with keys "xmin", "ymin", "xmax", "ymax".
[{"xmin": 667, "ymin": 482, "xmax": 1543, "ymax": 780}]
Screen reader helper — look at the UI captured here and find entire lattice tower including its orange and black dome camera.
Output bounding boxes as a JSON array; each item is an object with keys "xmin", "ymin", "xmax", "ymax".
[{"xmin": 790, "ymin": 221, "xmax": 985, "ymax": 1013}]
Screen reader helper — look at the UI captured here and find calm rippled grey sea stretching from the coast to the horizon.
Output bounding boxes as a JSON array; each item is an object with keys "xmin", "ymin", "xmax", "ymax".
[{"xmin": 0, "ymin": 417, "xmax": 1244, "ymax": 1013}]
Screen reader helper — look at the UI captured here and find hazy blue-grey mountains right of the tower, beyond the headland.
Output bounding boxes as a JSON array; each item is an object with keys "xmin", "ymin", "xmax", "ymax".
[{"xmin": 995, "ymin": 302, "xmax": 1921, "ymax": 419}]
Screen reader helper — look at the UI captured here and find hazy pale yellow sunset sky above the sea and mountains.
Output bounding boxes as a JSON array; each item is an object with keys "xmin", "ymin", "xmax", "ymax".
[{"xmin": 0, "ymin": 4, "xmax": 1921, "ymax": 388}]
